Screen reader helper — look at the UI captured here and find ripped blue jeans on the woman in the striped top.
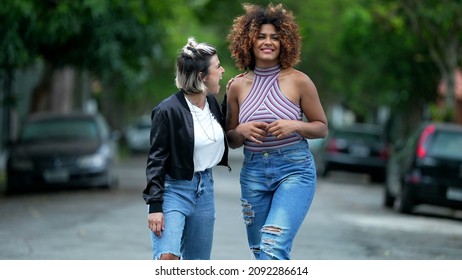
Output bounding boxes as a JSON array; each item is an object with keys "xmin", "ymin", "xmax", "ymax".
[{"xmin": 240, "ymin": 140, "xmax": 316, "ymax": 260}]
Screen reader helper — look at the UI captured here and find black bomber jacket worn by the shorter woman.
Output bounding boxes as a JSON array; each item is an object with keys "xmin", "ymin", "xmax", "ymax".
[{"xmin": 143, "ymin": 91, "xmax": 231, "ymax": 213}]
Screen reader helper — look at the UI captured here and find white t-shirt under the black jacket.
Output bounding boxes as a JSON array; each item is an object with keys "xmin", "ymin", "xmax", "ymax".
[{"xmin": 186, "ymin": 98, "xmax": 225, "ymax": 172}]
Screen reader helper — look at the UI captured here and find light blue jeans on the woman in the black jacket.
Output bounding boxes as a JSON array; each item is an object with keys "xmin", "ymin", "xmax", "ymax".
[{"xmin": 151, "ymin": 169, "xmax": 215, "ymax": 260}]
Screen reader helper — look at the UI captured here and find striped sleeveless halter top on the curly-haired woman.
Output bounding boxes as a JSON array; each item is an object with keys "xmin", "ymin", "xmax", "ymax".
[{"xmin": 239, "ymin": 65, "xmax": 303, "ymax": 152}]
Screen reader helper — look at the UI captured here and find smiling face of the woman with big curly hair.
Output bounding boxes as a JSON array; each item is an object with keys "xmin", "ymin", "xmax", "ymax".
[{"xmin": 253, "ymin": 24, "xmax": 281, "ymax": 68}]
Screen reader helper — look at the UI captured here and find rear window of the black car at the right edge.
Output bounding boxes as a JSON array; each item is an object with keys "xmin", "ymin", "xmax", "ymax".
[{"xmin": 428, "ymin": 131, "xmax": 462, "ymax": 159}]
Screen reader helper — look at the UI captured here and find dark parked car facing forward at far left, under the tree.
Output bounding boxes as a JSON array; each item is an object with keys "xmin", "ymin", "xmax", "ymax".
[{"xmin": 6, "ymin": 113, "xmax": 118, "ymax": 192}]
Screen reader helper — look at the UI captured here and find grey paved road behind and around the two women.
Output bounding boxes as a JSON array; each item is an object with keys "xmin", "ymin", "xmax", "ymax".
[{"xmin": 0, "ymin": 150, "xmax": 462, "ymax": 260}]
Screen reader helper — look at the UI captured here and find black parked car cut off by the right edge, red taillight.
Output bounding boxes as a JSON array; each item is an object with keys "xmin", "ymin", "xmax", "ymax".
[{"xmin": 383, "ymin": 123, "xmax": 462, "ymax": 213}]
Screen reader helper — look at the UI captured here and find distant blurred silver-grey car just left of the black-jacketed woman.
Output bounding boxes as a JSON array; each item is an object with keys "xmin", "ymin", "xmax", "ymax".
[{"xmin": 125, "ymin": 115, "xmax": 151, "ymax": 153}]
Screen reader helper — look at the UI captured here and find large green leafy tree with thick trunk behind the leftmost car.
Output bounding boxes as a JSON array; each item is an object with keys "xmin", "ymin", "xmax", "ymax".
[{"xmin": 0, "ymin": 0, "xmax": 173, "ymax": 136}]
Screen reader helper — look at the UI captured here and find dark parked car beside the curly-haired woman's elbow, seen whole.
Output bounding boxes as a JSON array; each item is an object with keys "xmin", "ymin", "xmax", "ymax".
[{"xmin": 316, "ymin": 123, "xmax": 389, "ymax": 182}]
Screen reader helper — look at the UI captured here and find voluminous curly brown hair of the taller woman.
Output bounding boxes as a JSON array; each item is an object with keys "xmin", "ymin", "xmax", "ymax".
[{"xmin": 227, "ymin": 3, "xmax": 302, "ymax": 70}]
